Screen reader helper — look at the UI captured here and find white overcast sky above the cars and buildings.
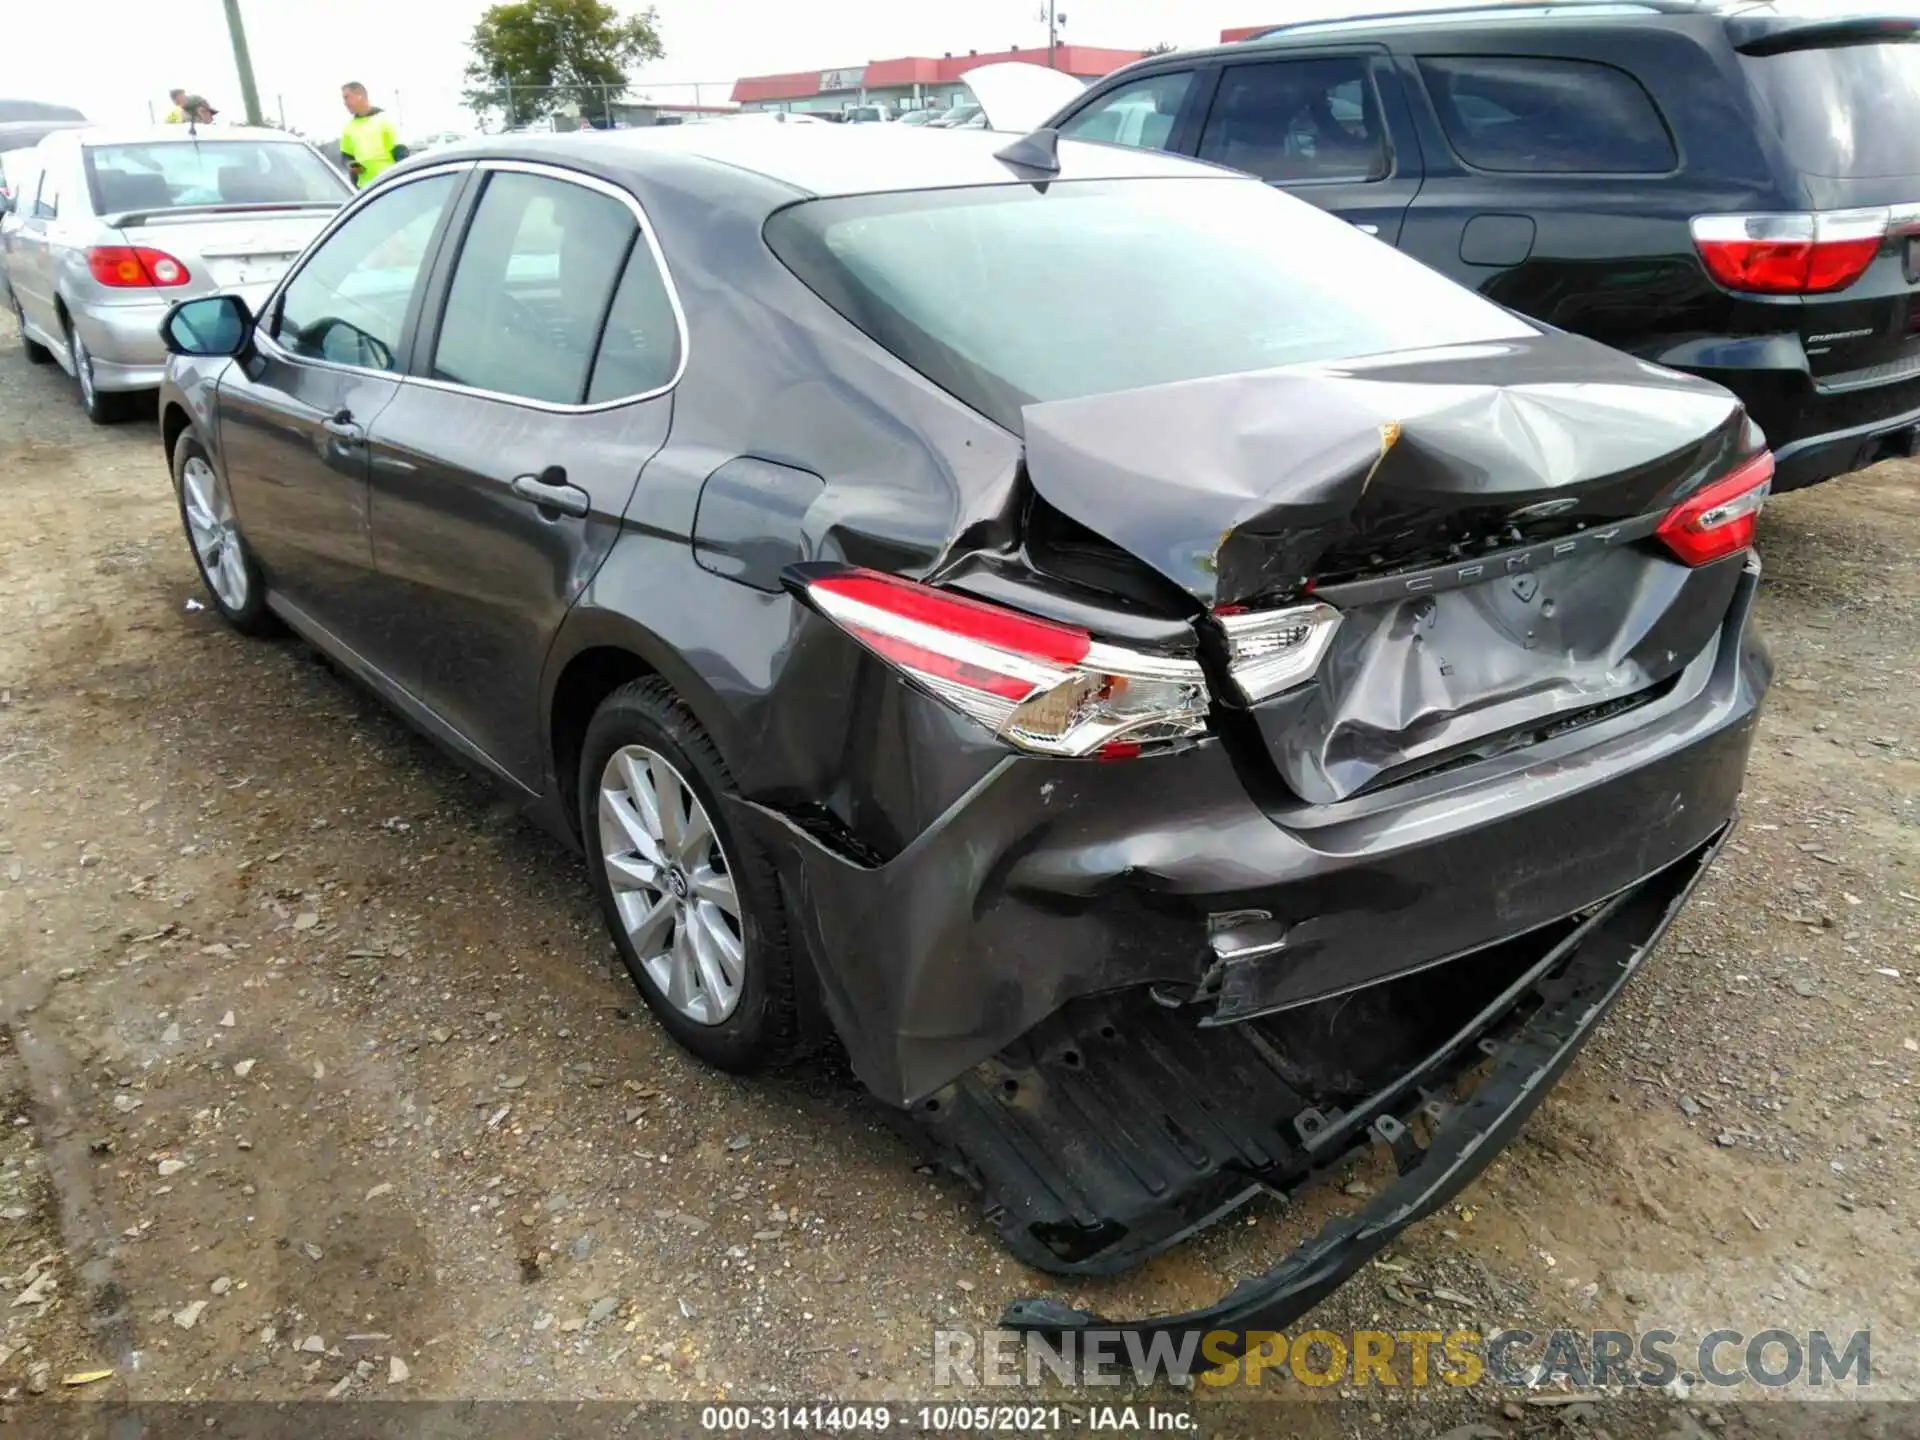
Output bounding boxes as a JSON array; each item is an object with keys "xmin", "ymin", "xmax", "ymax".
[{"xmin": 0, "ymin": 0, "xmax": 1290, "ymax": 132}]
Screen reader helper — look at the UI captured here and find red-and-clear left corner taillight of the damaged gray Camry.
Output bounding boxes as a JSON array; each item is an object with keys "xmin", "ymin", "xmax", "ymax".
[{"xmin": 793, "ymin": 568, "xmax": 1208, "ymax": 758}]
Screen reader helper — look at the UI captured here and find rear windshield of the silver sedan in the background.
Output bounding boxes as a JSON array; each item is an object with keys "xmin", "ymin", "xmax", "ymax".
[{"xmin": 86, "ymin": 140, "xmax": 348, "ymax": 215}]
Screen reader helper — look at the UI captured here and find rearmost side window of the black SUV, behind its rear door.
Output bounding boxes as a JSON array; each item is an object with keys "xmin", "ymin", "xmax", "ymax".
[{"xmin": 1419, "ymin": 56, "xmax": 1678, "ymax": 175}]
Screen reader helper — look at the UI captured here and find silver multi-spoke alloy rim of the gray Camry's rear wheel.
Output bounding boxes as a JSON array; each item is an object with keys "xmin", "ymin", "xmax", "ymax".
[{"xmin": 599, "ymin": 745, "xmax": 747, "ymax": 1025}]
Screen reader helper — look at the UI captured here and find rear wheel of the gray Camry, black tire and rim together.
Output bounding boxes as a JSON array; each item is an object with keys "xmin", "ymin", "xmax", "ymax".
[{"xmin": 578, "ymin": 678, "xmax": 801, "ymax": 1071}]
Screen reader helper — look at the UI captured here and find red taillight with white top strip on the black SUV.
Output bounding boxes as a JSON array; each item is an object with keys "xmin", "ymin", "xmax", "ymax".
[{"xmin": 1693, "ymin": 205, "xmax": 1893, "ymax": 296}]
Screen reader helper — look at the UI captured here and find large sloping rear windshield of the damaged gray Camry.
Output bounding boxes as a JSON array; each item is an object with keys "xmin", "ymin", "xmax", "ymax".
[{"xmin": 766, "ymin": 179, "xmax": 1536, "ymax": 432}]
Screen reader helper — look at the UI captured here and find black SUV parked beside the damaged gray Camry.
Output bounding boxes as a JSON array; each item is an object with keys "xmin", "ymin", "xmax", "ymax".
[{"xmin": 1050, "ymin": 0, "xmax": 1920, "ymax": 490}]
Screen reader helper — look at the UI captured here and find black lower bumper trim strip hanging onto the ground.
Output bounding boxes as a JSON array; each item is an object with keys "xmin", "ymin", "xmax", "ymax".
[{"xmin": 1002, "ymin": 824, "xmax": 1732, "ymax": 1361}]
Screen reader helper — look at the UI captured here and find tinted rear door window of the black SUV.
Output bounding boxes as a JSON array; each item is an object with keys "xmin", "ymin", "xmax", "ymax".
[{"xmin": 1200, "ymin": 56, "xmax": 1388, "ymax": 184}]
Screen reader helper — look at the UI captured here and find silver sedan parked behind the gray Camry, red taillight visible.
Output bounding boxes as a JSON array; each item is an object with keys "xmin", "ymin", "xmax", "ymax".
[{"xmin": 0, "ymin": 125, "xmax": 353, "ymax": 424}]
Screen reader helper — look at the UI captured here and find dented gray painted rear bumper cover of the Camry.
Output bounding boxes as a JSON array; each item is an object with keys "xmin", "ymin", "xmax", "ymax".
[{"xmin": 733, "ymin": 561, "xmax": 1772, "ymax": 1108}]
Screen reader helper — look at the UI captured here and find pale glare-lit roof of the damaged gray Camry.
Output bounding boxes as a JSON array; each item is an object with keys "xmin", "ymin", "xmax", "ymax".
[{"xmin": 434, "ymin": 123, "xmax": 1244, "ymax": 196}]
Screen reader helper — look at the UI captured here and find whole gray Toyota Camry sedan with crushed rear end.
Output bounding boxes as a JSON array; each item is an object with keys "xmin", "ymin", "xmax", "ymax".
[{"xmin": 161, "ymin": 125, "xmax": 1772, "ymax": 1367}]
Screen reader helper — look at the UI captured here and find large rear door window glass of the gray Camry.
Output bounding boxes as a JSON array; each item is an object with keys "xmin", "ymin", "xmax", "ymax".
[{"xmin": 434, "ymin": 171, "xmax": 633, "ymax": 405}]
